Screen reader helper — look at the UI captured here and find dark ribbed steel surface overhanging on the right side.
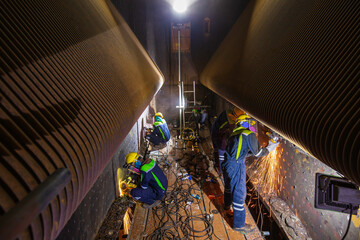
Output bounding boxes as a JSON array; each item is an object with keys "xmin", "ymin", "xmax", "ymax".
[{"xmin": 201, "ymin": 0, "xmax": 360, "ymax": 184}]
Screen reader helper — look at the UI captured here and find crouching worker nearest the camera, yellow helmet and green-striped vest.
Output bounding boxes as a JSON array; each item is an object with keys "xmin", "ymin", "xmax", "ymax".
[{"xmin": 125, "ymin": 152, "xmax": 168, "ymax": 208}]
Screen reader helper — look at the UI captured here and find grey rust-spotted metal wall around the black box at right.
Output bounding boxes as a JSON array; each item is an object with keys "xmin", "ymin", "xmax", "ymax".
[{"xmin": 270, "ymin": 141, "xmax": 360, "ymax": 240}]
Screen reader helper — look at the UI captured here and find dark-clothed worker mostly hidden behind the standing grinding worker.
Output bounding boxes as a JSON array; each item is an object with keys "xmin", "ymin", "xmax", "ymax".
[{"xmin": 210, "ymin": 107, "xmax": 244, "ymax": 170}]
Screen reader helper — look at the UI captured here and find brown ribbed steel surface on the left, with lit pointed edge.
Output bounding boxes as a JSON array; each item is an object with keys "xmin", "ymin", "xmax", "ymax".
[{"xmin": 0, "ymin": 0, "xmax": 163, "ymax": 239}]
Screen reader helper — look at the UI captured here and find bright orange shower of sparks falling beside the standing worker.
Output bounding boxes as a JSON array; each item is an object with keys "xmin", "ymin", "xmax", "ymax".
[{"xmin": 248, "ymin": 148, "xmax": 282, "ymax": 194}]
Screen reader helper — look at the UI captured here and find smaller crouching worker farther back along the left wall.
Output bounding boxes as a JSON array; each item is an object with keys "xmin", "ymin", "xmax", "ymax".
[{"xmin": 145, "ymin": 112, "xmax": 170, "ymax": 146}]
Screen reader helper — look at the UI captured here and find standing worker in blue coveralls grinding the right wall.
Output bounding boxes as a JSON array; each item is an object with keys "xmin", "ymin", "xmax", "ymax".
[{"xmin": 222, "ymin": 114, "xmax": 278, "ymax": 233}]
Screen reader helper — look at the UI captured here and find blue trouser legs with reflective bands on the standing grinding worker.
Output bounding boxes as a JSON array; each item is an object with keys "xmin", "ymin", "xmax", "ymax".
[{"xmin": 223, "ymin": 160, "xmax": 246, "ymax": 228}]
